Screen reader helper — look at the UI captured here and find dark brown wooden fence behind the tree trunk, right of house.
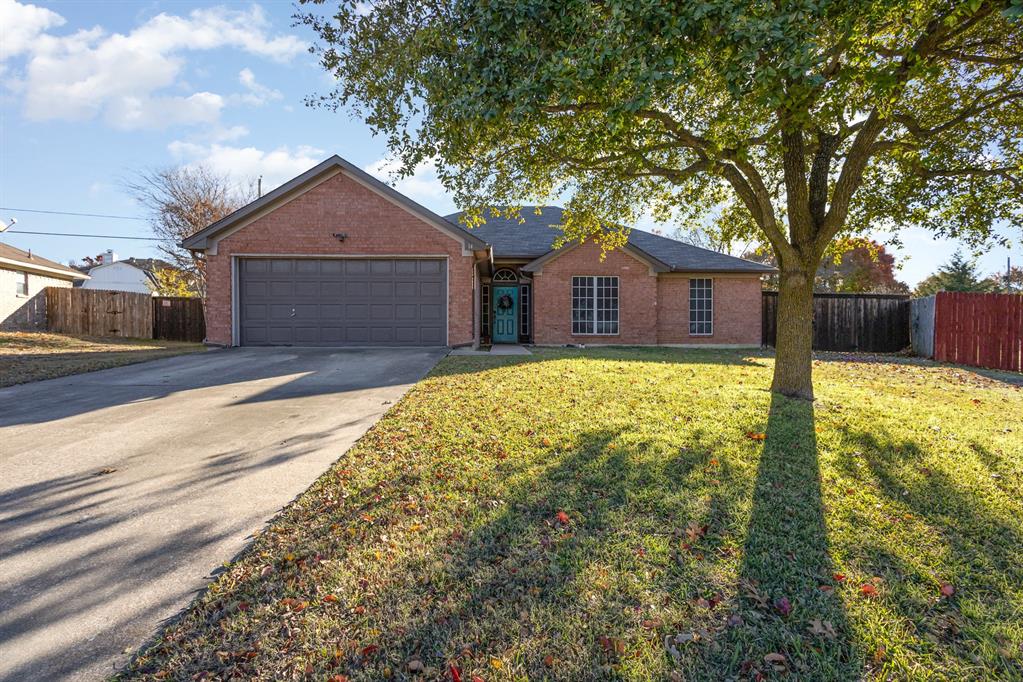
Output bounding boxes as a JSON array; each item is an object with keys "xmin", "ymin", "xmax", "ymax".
[{"xmin": 761, "ymin": 291, "xmax": 909, "ymax": 353}]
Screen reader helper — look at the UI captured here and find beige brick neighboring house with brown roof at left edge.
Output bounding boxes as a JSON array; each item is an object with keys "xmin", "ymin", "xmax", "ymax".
[{"xmin": 0, "ymin": 243, "xmax": 89, "ymax": 331}]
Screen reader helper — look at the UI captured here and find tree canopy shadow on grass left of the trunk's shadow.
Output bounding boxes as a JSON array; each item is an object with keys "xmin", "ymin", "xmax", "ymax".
[{"xmin": 125, "ymin": 429, "xmax": 743, "ymax": 680}]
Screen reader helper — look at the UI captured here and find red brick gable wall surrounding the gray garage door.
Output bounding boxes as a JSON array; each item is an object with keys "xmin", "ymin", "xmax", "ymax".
[{"xmin": 207, "ymin": 170, "xmax": 473, "ymax": 346}]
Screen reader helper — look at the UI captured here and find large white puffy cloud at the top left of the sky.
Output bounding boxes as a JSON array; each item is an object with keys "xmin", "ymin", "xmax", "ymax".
[{"xmin": 0, "ymin": 0, "xmax": 305, "ymax": 129}]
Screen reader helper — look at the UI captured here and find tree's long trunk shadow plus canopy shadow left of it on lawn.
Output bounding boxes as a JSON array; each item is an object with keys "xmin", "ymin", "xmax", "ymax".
[{"xmin": 119, "ymin": 397, "xmax": 862, "ymax": 680}]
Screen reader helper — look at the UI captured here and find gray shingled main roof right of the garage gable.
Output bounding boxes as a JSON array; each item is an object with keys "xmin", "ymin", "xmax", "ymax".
[{"xmin": 446, "ymin": 207, "xmax": 774, "ymax": 273}]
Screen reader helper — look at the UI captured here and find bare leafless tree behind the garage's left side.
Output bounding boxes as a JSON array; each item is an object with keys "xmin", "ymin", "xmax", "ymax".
[{"xmin": 125, "ymin": 166, "xmax": 256, "ymax": 298}]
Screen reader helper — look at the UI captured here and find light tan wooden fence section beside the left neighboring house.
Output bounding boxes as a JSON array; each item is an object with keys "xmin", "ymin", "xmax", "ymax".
[{"xmin": 46, "ymin": 286, "xmax": 152, "ymax": 338}]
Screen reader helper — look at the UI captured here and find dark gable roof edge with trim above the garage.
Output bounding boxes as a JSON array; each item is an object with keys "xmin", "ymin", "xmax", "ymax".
[{"xmin": 181, "ymin": 154, "xmax": 487, "ymax": 251}]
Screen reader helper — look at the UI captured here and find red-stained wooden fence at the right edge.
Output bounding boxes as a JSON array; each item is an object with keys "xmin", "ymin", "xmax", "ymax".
[{"xmin": 934, "ymin": 291, "xmax": 1023, "ymax": 372}]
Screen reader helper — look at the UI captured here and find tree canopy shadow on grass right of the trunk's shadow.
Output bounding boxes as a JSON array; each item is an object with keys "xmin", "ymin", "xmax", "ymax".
[{"xmin": 826, "ymin": 426, "xmax": 1023, "ymax": 679}]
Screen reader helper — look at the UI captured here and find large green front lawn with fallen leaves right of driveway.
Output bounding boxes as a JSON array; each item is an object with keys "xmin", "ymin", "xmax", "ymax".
[{"xmin": 117, "ymin": 349, "xmax": 1023, "ymax": 681}]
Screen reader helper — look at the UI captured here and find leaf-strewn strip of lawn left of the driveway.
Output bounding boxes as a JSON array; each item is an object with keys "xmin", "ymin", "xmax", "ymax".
[{"xmin": 0, "ymin": 331, "xmax": 205, "ymax": 388}]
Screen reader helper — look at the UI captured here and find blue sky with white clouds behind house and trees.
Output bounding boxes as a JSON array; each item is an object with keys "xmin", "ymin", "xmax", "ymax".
[{"xmin": 0, "ymin": 0, "xmax": 1023, "ymax": 284}]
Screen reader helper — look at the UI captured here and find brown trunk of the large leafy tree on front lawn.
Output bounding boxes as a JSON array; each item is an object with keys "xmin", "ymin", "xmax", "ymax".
[{"xmin": 770, "ymin": 264, "xmax": 814, "ymax": 400}]
